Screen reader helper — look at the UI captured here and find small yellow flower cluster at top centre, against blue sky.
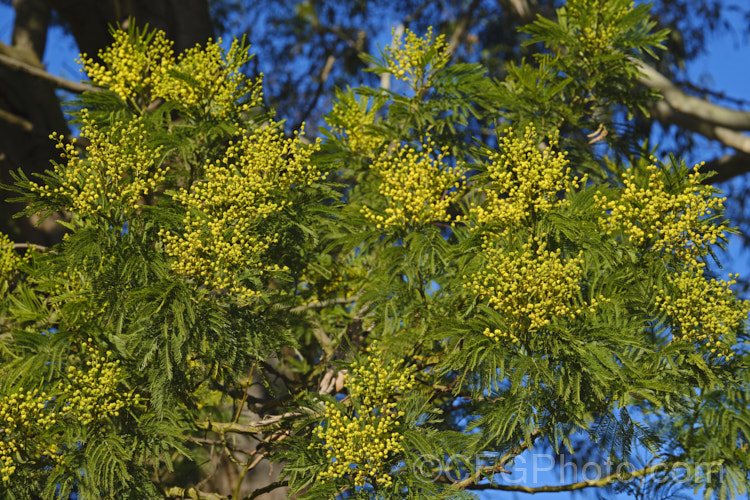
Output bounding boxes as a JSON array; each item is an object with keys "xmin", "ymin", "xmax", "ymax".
[{"xmin": 385, "ymin": 26, "xmax": 451, "ymax": 90}]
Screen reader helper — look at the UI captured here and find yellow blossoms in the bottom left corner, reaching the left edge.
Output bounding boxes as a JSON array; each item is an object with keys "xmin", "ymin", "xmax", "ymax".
[{"xmin": 0, "ymin": 339, "xmax": 129, "ymax": 482}]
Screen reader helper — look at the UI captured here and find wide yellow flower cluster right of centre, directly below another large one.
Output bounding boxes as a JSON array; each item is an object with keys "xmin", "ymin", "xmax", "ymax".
[{"xmin": 464, "ymin": 234, "xmax": 604, "ymax": 336}]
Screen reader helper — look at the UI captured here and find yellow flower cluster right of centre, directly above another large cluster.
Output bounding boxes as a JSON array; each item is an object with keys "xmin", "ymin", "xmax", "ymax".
[{"xmin": 473, "ymin": 125, "xmax": 585, "ymax": 229}]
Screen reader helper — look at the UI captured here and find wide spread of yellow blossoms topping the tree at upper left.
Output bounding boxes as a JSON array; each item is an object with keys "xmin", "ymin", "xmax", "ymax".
[{"xmin": 79, "ymin": 31, "xmax": 263, "ymax": 118}]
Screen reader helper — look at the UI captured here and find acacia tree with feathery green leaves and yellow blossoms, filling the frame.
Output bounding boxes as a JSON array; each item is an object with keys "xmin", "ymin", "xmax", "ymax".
[{"xmin": 0, "ymin": 0, "xmax": 750, "ymax": 499}]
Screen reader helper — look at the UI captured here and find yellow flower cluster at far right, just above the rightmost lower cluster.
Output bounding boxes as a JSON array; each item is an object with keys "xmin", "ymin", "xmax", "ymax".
[{"xmin": 595, "ymin": 165, "xmax": 726, "ymax": 267}]
